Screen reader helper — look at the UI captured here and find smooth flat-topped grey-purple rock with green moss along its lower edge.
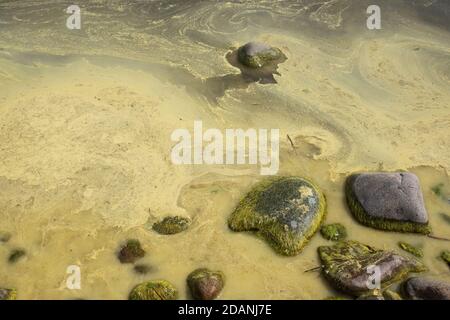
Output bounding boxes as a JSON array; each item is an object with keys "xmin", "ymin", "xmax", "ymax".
[{"xmin": 345, "ymin": 172, "xmax": 431, "ymax": 234}]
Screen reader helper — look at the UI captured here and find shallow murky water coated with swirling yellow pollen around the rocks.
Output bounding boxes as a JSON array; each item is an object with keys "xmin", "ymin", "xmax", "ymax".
[{"xmin": 0, "ymin": 0, "xmax": 450, "ymax": 299}]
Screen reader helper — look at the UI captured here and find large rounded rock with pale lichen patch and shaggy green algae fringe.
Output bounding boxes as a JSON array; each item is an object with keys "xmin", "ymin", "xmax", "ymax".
[{"xmin": 228, "ymin": 177, "xmax": 326, "ymax": 256}]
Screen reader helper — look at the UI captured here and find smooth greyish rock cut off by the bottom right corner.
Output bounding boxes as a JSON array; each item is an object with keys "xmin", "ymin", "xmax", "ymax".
[{"xmin": 402, "ymin": 278, "xmax": 450, "ymax": 300}]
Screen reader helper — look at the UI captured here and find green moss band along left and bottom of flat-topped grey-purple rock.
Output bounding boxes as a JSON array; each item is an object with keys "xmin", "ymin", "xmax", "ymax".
[{"xmin": 345, "ymin": 175, "xmax": 431, "ymax": 234}]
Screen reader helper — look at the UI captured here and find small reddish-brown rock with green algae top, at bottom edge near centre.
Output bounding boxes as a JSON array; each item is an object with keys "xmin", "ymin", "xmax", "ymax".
[{"xmin": 187, "ymin": 268, "xmax": 225, "ymax": 300}]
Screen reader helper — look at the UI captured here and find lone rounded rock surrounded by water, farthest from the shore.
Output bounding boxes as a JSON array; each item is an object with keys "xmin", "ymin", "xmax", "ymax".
[{"xmin": 238, "ymin": 42, "xmax": 284, "ymax": 68}]
